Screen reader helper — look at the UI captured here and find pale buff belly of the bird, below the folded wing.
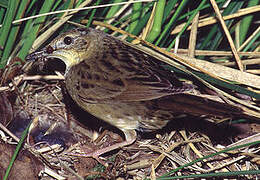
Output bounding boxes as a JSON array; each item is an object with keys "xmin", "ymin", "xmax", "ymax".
[{"xmin": 77, "ymin": 102, "xmax": 172, "ymax": 131}]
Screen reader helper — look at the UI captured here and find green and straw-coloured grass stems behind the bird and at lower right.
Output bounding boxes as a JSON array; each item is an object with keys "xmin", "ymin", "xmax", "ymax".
[{"xmin": 0, "ymin": 0, "xmax": 260, "ymax": 179}]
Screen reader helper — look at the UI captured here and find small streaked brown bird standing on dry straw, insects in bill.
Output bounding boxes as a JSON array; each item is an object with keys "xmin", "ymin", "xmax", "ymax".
[{"xmin": 26, "ymin": 28, "xmax": 248, "ymax": 157}]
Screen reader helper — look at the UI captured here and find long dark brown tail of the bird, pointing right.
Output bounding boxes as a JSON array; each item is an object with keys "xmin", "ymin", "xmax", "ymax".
[{"xmin": 157, "ymin": 94, "xmax": 260, "ymax": 120}]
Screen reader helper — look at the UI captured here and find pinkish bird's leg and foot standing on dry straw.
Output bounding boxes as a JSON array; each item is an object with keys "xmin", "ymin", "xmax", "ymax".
[{"xmin": 70, "ymin": 130, "xmax": 137, "ymax": 164}]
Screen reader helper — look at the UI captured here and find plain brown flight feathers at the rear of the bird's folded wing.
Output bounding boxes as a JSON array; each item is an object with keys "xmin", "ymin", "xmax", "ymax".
[{"xmin": 109, "ymin": 67, "xmax": 192, "ymax": 101}]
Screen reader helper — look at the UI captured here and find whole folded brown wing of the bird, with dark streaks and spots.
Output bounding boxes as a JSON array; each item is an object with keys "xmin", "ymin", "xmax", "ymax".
[{"xmin": 68, "ymin": 42, "xmax": 193, "ymax": 102}]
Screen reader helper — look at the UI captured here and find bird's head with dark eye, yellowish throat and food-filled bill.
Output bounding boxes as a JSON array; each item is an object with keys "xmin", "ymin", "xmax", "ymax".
[{"xmin": 26, "ymin": 28, "xmax": 102, "ymax": 70}]
